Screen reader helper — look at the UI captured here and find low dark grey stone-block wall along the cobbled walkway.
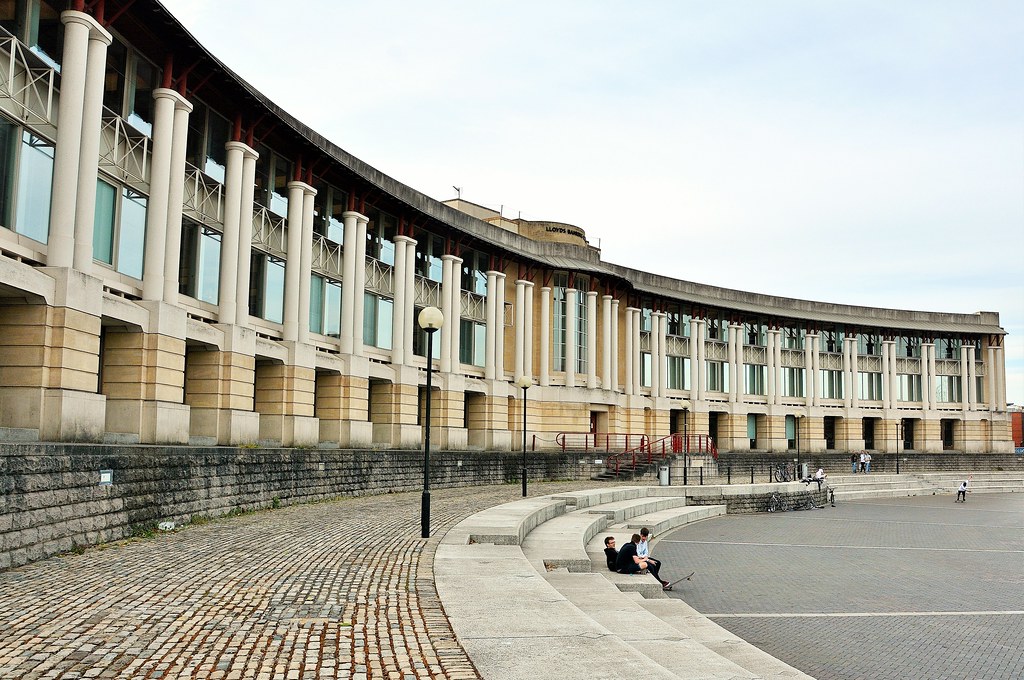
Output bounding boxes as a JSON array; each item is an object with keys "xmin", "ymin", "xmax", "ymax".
[{"xmin": 0, "ymin": 443, "xmax": 589, "ymax": 568}]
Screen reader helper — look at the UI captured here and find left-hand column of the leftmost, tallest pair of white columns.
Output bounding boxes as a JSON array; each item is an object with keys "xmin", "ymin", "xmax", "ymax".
[{"xmin": 46, "ymin": 10, "xmax": 95, "ymax": 267}]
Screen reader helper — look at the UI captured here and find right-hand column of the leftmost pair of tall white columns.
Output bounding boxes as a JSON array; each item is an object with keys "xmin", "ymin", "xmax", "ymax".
[{"xmin": 72, "ymin": 26, "xmax": 112, "ymax": 274}]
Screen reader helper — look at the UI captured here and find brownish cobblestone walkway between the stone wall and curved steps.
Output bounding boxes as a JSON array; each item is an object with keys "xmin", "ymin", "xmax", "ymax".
[{"xmin": 0, "ymin": 481, "xmax": 606, "ymax": 680}]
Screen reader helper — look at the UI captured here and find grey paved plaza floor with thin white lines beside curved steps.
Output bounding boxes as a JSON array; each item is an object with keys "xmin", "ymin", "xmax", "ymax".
[{"xmin": 654, "ymin": 494, "xmax": 1024, "ymax": 680}]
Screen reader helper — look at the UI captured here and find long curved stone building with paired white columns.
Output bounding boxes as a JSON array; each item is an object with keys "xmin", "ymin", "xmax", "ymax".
[{"xmin": 0, "ymin": 0, "xmax": 1012, "ymax": 453}]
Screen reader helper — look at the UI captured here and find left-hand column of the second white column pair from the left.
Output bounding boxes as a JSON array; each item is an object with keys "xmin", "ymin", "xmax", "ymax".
[{"xmin": 140, "ymin": 88, "xmax": 176, "ymax": 300}]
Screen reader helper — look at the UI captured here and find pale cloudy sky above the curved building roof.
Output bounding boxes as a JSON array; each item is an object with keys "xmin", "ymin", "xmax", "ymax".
[{"xmin": 164, "ymin": 0, "xmax": 1024, "ymax": 403}]
